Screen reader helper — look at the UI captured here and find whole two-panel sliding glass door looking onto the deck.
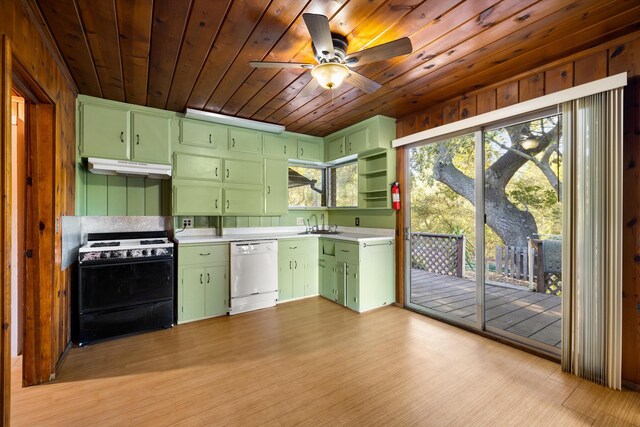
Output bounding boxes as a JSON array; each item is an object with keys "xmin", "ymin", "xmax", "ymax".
[{"xmin": 405, "ymin": 114, "xmax": 562, "ymax": 354}]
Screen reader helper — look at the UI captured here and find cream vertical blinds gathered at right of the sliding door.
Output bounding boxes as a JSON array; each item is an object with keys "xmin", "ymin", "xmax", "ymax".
[{"xmin": 562, "ymin": 88, "xmax": 622, "ymax": 389}]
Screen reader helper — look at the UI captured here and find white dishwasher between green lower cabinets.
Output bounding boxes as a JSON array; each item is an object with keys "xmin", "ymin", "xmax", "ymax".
[{"xmin": 229, "ymin": 240, "xmax": 278, "ymax": 315}]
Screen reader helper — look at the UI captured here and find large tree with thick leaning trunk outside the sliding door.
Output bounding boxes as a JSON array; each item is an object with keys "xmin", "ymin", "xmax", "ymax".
[{"xmin": 416, "ymin": 116, "xmax": 561, "ymax": 246}]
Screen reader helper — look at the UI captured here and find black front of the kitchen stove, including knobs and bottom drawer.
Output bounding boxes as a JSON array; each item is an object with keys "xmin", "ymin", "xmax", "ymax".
[{"xmin": 74, "ymin": 232, "xmax": 174, "ymax": 346}]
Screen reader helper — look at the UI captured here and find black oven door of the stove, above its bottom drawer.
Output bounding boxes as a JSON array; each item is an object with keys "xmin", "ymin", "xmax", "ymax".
[{"xmin": 78, "ymin": 258, "xmax": 173, "ymax": 314}]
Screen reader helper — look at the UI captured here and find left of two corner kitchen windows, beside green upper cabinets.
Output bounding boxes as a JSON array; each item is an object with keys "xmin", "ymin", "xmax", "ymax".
[{"xmin": 289, "ymin": 165, "xmax": 327, "ymax": 208}]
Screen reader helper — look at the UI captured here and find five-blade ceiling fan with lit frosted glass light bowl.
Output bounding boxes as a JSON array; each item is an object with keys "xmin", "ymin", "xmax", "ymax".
[{"xmin": 249, "ymin": 13, "xmax": 413, "ymax": 96}]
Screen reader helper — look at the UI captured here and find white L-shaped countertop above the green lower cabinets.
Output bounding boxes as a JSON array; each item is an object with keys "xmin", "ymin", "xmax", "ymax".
[{"xmin": 173, "ymin": 227, "xmax": 395, "ymax": 244}]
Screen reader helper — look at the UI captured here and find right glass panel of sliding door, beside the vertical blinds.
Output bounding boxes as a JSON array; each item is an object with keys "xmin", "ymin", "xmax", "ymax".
[{"xmin": 483, "ymin": 115, "xmax": 562, "ymax": 352}]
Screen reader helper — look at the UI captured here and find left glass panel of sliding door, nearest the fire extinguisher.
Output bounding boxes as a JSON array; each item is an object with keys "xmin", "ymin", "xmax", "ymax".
[{"xmin": 407, "ymin": 133, "xmax": 480, "ymax": 327}]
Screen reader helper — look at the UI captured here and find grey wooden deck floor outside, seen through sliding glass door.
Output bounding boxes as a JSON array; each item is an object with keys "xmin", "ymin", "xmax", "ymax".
[{"xmin": 411, "ymin": 269, "xmax": 562, "ymax": 348}]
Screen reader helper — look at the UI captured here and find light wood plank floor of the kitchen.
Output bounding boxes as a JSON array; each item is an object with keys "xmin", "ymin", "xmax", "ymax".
[{"xmin": 12, "ymin": 297, "xmax": 640, "ymax": 426}]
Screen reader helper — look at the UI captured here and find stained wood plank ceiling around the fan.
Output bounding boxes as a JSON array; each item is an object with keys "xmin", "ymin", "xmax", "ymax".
[{"xmin": 36, "ymin": 0, "xmax": 640, "ymax": 135}]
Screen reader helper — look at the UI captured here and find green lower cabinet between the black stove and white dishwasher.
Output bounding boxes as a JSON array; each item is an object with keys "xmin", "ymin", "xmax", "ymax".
[{"xmin": 178, "ymin": 243, "xmax": 229, "ymax": 323}]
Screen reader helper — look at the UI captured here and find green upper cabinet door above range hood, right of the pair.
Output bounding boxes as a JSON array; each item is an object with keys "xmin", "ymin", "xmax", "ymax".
[{"xmin": 131, "ymin": 111, "xmax": 171, "ymax": 165}]
